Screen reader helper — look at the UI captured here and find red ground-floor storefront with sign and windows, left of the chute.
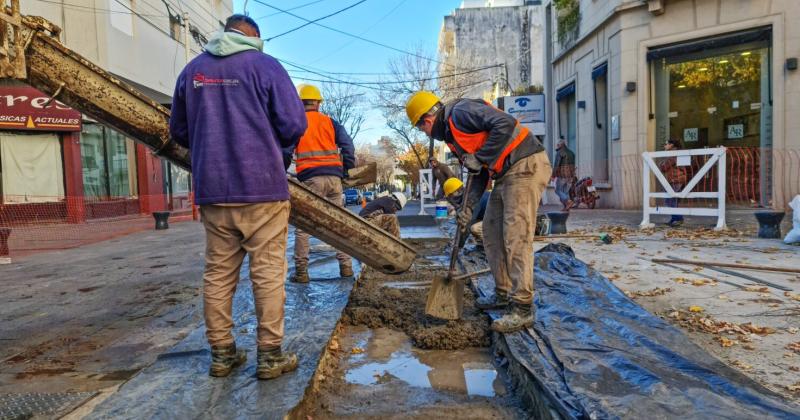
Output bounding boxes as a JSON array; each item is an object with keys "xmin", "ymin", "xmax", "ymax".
[{"xmin": 0, "ymin": 83, "xmax": 191, "ymax": 226}]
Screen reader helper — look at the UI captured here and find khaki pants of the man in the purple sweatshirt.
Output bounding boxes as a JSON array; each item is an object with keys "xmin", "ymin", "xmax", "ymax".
[{"xmin": 200, "ymin": 201, "xmax": 289, "ymax": 347}]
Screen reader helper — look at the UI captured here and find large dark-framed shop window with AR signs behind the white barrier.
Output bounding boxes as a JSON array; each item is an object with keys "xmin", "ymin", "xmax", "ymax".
[{"xmin": 648, "ymin": 29, "xmax": 772, "ymax": 205}]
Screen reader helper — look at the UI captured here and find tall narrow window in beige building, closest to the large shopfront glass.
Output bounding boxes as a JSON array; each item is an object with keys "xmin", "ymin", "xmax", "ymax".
[{"xmin": 592, "ymin": 63, "xmax": 610, "ymax": 183}]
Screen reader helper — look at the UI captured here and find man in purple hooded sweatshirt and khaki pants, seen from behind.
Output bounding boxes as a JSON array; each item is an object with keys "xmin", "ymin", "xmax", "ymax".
[{"xmin": 170, "ymin": 15, "xmax": 306, "ymax": 379}]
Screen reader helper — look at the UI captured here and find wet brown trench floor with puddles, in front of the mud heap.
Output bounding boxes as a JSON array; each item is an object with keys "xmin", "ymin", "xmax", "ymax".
[{"xmin": 302, "ymin": 326, "xmax": 528, "ymax": 419}]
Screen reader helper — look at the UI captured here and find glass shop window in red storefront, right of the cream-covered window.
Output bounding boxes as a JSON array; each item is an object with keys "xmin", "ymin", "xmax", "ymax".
[{"xmin": 81, "ymin": 124, "xmax": 138, "ymax": 200}]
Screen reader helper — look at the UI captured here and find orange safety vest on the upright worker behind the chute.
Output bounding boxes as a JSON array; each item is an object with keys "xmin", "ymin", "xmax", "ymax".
[{"xmin": 295, "ymin": 111, "xmax": 342, "ymax": 174}]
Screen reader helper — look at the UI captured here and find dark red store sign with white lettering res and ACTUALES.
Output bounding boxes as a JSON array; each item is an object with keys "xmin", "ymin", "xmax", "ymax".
[{"xmin": 0, "ymin": 86, "xmax": 81, "ymax": 131}]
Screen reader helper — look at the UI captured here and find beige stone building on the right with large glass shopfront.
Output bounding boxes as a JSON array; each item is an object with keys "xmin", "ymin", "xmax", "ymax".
[{"xmin": 544, "ymin": 0, "xmax": 800, "ymax": 208}]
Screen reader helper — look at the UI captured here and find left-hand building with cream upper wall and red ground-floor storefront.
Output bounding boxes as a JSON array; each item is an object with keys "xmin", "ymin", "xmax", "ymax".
[{"xmin": 0, "ymin": 0, "xmax": 232, "ymax": 225}]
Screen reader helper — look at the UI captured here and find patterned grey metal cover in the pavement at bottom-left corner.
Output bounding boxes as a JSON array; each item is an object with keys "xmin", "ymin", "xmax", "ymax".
[{"xmin": 0, "ymin": 392, "xmax": 95, "ymax": 420}]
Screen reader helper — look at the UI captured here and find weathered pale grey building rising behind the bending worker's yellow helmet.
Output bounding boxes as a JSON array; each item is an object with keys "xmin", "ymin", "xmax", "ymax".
[{"xmin": 438, "ymin": 0, "xmax": 544, "ymax": 101}]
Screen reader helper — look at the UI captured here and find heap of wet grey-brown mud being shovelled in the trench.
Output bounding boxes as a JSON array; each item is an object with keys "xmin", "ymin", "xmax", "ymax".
[{"xmin": 342, "ymin": 265, "xmax": 490, "ymax": 350}]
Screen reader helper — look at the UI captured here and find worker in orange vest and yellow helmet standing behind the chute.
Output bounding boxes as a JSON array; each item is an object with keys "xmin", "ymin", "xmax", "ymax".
[{"xmin": 292, "ymin": 85, "xmax": 356, "ymax": 283}]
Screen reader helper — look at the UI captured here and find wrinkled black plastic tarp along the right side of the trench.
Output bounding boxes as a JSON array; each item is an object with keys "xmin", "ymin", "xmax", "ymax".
[{"xmin": 477, "ymin": 244, "xmax": 800, "ymax": 419}]
